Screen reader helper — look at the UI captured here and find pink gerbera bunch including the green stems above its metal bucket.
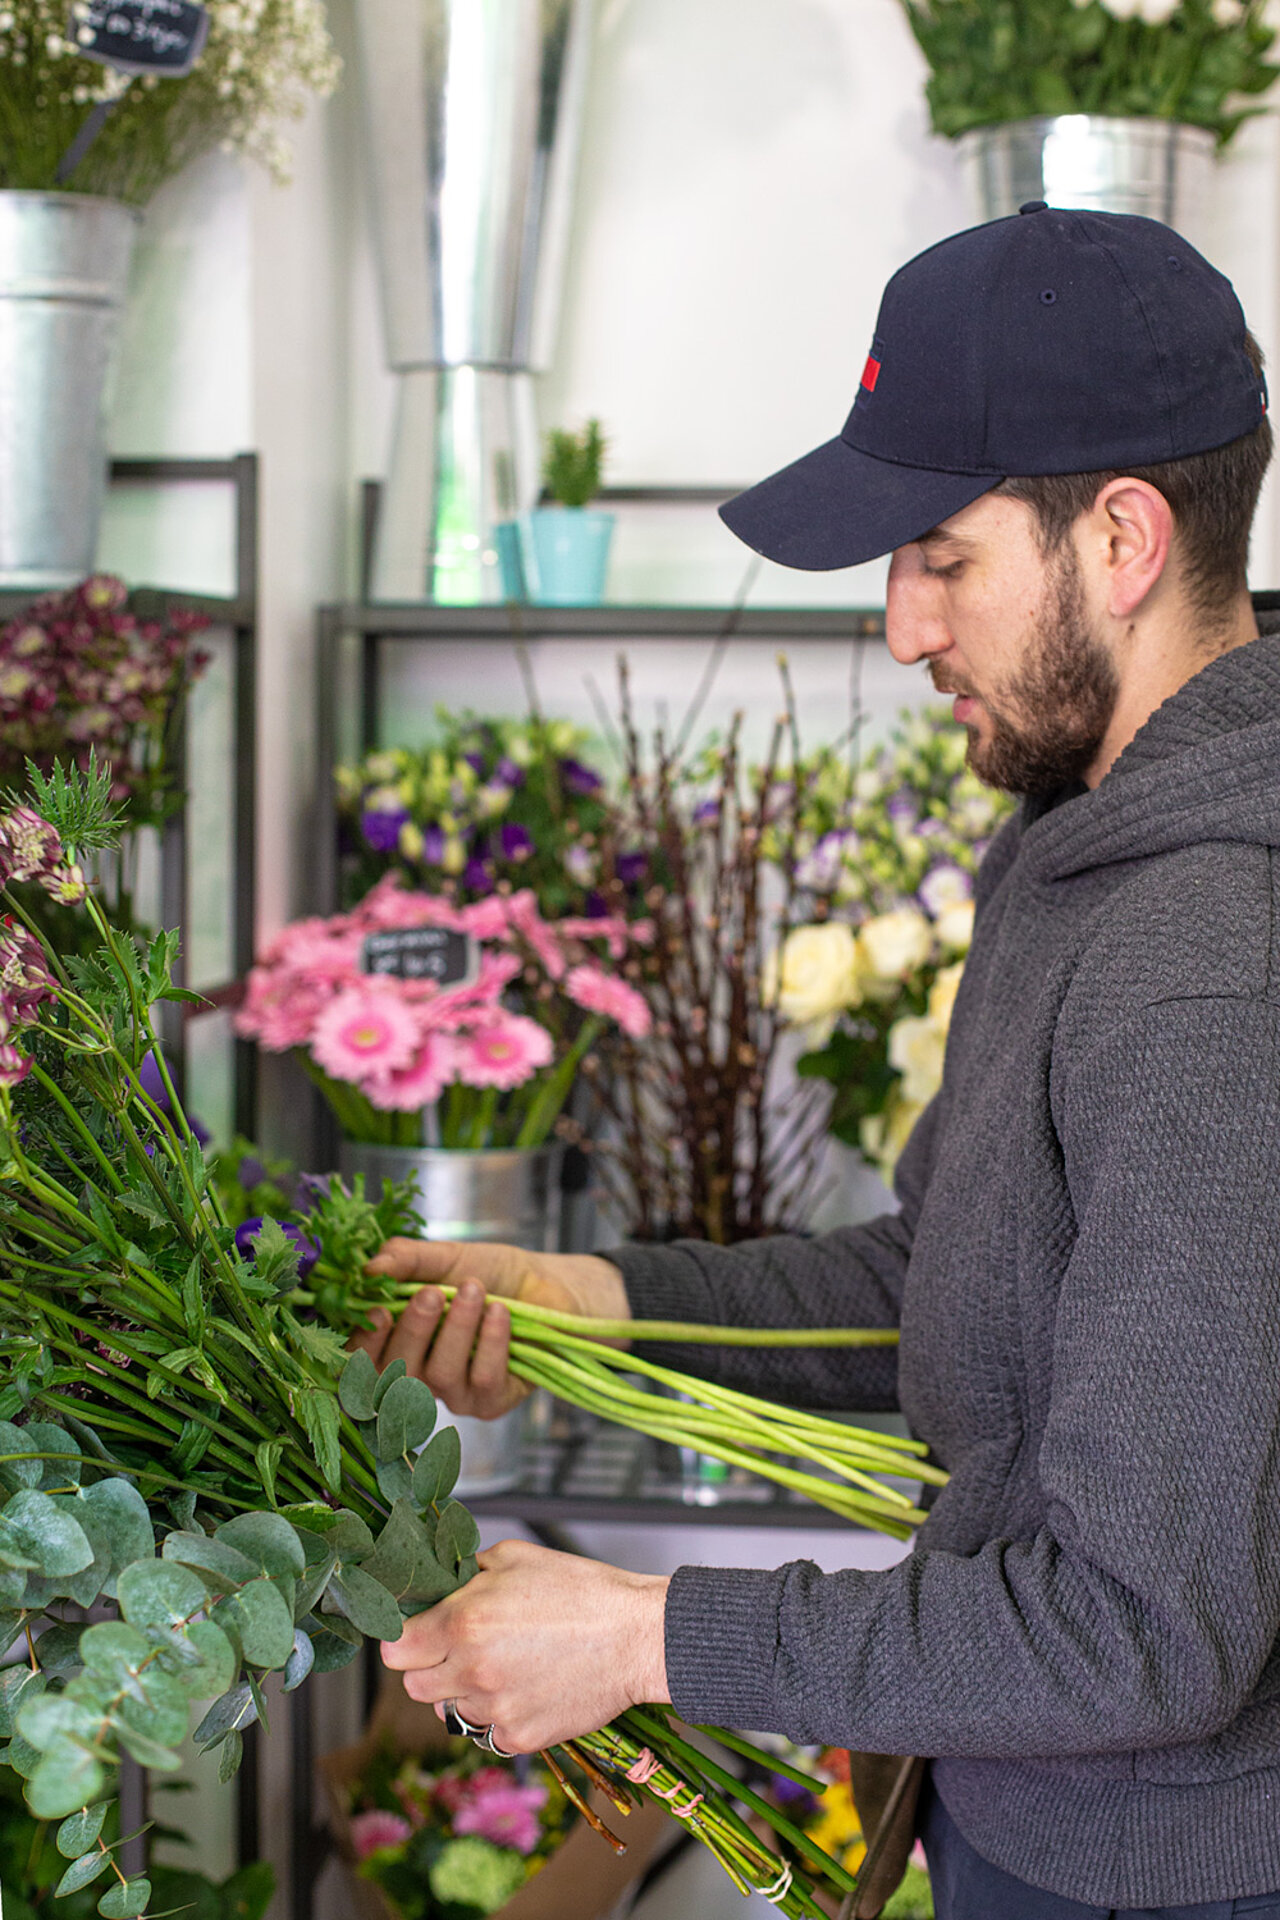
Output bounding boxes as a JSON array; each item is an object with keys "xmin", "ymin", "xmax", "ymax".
[{"xmin": 236, "ymin": 876, "xmax": 651, "ymax": 1148}]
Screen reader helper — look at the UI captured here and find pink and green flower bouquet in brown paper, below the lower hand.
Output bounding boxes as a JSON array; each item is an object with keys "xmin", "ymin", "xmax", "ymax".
[{"xmin": 347, "ymin": 1740, "xmax": 576, "ymax": 1920}]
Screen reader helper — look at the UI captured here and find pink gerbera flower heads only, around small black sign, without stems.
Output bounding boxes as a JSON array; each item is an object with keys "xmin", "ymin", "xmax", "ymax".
[{"xmin": 236, "ymin": 874, "xmax": 651, "ymax": 1114}]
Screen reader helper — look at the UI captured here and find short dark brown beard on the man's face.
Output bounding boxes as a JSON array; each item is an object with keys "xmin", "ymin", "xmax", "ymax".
[{"xmin": 929, "ymin": 549, "xmax": 1121, "ymax": 793}]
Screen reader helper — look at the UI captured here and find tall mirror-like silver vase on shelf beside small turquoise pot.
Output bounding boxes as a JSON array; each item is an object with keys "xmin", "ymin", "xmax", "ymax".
[{"xmin": 355, "ymin": 0, "xmax": 591, "ymax": 605}]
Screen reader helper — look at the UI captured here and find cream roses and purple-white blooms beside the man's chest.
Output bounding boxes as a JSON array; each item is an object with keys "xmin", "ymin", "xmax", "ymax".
[{"xmin": 764, "ymin": 708, "xmax": 1011, "ymax": 1177}]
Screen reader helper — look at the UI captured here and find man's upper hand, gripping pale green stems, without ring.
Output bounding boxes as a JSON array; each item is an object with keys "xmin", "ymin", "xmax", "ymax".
[{"xmin": 347, "ymin": 1238, "xmax": 631, "ymax": 1421}]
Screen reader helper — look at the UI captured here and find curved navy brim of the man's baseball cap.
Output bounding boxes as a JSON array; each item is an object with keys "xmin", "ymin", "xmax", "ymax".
[{"xmin": 720, "ymin": 438, "xmax": 1002, "ymax": 572}]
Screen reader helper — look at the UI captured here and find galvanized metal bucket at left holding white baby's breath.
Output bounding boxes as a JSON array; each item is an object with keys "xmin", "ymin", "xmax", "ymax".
[{"xmin": 0, "ymin": 190, "xmax": 140, "ymax": 588}]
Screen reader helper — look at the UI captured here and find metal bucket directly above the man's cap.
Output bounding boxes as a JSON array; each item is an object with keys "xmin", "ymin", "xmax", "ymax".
[{"xmin": 956, "ymin": 113, "xmax": 1217, "ymax": 236}]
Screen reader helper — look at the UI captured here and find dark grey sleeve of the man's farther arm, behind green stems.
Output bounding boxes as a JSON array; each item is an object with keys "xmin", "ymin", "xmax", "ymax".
[{"xmin": 604, "ymin": 1102, "xmax": 936, "ymax": 1411}]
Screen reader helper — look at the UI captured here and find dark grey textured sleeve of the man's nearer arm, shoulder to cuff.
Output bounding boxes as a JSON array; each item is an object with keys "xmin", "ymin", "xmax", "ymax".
[{"xmin": 666, "ymin": 996, "xmax": 1280, "ymax": 1759}]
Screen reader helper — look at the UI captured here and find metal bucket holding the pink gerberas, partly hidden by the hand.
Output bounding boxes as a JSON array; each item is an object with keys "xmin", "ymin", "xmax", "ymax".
[{"xmin": 340, "ymin": 1140, "xmax": 564, "ymax": 1496}]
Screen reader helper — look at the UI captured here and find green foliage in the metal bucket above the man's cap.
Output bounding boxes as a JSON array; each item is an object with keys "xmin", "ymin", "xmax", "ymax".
[{"xmin": 904, "ymin": 0, "xmax": 1280, "ymax": 146}]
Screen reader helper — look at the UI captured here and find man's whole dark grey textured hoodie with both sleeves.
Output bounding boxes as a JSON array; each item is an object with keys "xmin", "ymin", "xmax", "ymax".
[{"xmin": 610, "ymin": 636, "xmax": 1280, "ymax": 1908}]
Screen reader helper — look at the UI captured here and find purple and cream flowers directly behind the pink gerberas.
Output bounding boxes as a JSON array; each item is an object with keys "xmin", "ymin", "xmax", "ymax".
[{"xmin": 334, "ymin": 708, "xmax": 621, "ymax": 920}]
